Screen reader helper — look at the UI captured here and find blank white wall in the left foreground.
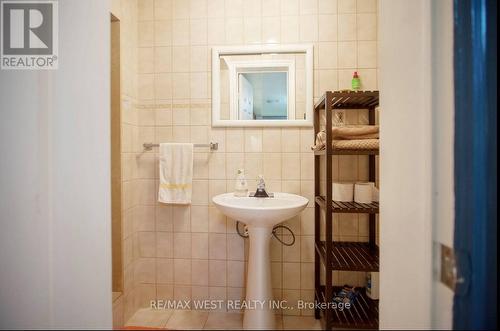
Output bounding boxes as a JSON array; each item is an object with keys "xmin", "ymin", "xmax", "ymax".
[{"xmin": 0, "ymin": 0, "xmax": 111, "ymax": 328}]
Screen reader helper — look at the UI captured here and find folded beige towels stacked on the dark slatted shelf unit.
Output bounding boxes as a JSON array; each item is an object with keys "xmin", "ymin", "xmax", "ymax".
[{"xmin": 311, "ymin": 125, "xmax": 379, "ymax": 151}]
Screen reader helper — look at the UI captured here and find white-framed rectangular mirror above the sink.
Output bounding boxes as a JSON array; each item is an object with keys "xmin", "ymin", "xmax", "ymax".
[{"xmin": 212, "ymin": 45, "xmax": 313, "ymax": 127}]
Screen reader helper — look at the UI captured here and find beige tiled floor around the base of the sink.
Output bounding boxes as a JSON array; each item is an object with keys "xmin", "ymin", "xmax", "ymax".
[{"xmin": 125, "ymin": 308, "xmax": 321, "ymax": 330}]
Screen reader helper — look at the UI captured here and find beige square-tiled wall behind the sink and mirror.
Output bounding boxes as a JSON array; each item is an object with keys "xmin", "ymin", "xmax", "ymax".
[{"xmin": 131, "ymin": 0, "xmax": 377, "ymax": 315}]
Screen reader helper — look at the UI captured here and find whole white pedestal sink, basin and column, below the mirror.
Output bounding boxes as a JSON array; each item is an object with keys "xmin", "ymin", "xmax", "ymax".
[{"xmin": 212, "ymin": 193, "xmax": 308, "ymax": 330}]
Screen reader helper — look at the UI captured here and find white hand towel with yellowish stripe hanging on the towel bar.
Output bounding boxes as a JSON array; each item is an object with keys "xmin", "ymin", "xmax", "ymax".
[{"xmin": 158, "ymin": 143, "xmax": 193, "ymax": 204}]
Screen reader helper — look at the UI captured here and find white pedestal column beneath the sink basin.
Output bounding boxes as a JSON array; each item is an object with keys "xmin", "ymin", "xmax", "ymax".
[{"xmin": 243, "ymin": 226, "xmax": 276, "ymax": 330}]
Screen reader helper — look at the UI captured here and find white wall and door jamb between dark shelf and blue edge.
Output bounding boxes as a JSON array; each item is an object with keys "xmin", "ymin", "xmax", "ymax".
[{"xmin": 379, "ymin": 0, "xmax": 454, "ymax": 329}]
